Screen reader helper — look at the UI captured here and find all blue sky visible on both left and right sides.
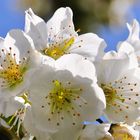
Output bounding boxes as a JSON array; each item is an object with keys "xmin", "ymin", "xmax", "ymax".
[{"xmin": 0, "ymin": 0, "xmax": 140, "ymax": 50}]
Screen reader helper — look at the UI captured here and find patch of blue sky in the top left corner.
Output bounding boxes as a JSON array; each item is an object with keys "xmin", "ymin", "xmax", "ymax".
[{"xmin": 0, "ymin": 0, "xmax": 24, "ymax": 37}]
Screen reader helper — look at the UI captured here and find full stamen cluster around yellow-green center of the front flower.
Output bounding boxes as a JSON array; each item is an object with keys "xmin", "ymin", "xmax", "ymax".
[{"xmin": 41, "ymin": 80, "xmax": 87, "ymax": 127}]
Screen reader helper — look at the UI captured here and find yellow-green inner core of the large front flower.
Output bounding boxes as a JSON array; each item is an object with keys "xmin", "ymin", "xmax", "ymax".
[{"xmin": 48, "ymin": 80, "xmax": 82, "ymax": 113}]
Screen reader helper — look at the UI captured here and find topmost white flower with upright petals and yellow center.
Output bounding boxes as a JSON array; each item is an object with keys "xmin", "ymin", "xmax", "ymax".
[{"xmin": 25, "ymin": 7, "xmax": 106, "ymax": 60}]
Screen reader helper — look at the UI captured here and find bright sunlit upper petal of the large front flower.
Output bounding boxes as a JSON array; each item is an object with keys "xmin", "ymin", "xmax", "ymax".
[{"xmin": 56, "ymin": 54, "xmax": 97, "ymax": 83}]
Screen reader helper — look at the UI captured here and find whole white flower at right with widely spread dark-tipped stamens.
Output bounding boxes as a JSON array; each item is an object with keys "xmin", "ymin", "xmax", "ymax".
[{"xmin": 96, "ymin": 51, "xmax": 140, "ymax": 122}]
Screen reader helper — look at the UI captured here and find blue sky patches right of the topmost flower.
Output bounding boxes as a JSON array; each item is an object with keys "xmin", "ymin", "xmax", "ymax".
[{"xmin": 98, "ymin": 2, "xmax": 140, "ymax": 50}]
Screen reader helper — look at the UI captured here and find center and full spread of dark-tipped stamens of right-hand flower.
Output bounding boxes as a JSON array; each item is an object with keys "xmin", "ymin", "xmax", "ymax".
[{"xmin": 101, "ymin": 76, "xmax": 140, "ymax": 120}]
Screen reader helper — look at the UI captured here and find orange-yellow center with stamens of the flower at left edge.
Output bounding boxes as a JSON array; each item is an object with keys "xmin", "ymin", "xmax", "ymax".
[{"xmin": 0, "ymin": 53, "xmax": 27, "ymax": 88}]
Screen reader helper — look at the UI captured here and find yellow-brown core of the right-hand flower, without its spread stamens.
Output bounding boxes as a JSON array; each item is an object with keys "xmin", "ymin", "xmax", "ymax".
[{"xmin": 101, "ymin": 84, "xmax": 124, "ymax": 106}]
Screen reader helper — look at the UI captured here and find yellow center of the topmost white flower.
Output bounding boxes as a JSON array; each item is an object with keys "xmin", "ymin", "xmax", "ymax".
[{"xmin": 43, "ymin": 37, "xmax": 74, "ymax": 60}]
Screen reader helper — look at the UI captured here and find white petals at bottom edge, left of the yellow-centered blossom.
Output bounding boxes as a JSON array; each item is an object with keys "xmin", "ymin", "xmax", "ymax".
[{"xmin": 78, "ymin": 124, "xmax": 113, "ymax": 140}]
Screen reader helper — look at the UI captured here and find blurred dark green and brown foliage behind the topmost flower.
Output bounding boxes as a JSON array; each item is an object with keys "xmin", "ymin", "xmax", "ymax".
[{"xmin": 20, "ymin": 0, "xmax": 133, "ymax": 33}]
